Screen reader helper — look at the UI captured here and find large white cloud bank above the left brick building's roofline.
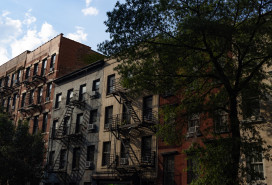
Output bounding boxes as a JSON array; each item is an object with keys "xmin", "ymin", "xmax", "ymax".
[{"xmin": 0, "ymin": 9, "xmax": 56, "ymax": 64}]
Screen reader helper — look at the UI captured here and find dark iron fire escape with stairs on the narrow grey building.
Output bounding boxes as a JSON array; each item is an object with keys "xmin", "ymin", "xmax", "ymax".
[{"xmin": 46, "ymin": 93, "xmax": 90, "ymax": 185}]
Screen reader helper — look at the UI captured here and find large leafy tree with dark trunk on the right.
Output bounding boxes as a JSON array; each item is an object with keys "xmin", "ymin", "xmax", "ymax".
[{"xmin": 99, "ymin": 0, "xmax": 272, "ymax": 184}]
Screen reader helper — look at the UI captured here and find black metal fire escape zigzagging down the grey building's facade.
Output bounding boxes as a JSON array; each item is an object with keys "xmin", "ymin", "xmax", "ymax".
[{"xmin": 46, "ymin": 97, "xmax": 90, "ymax": 184}]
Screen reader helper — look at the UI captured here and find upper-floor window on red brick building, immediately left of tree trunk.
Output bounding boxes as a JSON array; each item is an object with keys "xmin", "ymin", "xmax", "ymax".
[{"xmin": 213, "ymin": 111, "xmax": 229, "ymax": 133}]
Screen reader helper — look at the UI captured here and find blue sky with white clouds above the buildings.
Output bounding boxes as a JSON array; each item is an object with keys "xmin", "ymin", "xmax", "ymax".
[{"xmin": 0, "ymin": 0, "xmax": 120, "ymax": 65}]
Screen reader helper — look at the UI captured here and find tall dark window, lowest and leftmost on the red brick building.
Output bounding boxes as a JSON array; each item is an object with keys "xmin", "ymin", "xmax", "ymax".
[{"xmin": 163, "ymin": 155, "xmax": 175, "ymax": 185}]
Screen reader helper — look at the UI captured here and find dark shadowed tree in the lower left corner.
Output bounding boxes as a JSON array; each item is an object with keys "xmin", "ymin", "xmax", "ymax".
[{"xmin": 0, "ymin": 113, "xmax": 45, "ymax": 185}]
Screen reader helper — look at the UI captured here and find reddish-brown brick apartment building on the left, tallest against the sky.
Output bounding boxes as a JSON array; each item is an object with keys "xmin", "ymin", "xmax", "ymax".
[{"xmin": 0, "ymin": 34, "xmax": 100, "ymax": 150}]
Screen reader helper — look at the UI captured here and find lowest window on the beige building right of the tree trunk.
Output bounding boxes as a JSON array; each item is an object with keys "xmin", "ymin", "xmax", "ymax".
[{"xmin": 248, "ymin": 152, "xmax": 264, "ymax": 180}]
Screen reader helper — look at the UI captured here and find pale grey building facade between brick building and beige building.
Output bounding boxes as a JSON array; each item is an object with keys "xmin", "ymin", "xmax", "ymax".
[{"xmin": 44, "ymin": 61, "xmax": 104, "ymax": 185}]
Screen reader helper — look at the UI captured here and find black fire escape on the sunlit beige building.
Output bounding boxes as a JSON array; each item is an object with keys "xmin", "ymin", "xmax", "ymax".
[{"xmin": 107, "ymin": 80, "xmax": 158, "ymax": 180}]
